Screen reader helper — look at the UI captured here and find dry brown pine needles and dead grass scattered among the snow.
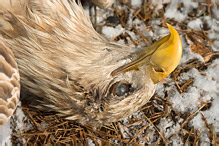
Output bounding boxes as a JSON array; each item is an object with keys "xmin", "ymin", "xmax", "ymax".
[{"xmin": 12, "ymin": 0, "xmax": 219, "ymax": 145}]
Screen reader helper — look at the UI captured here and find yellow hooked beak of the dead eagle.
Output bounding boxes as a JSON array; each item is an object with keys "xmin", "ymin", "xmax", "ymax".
[{"xmin": 111, "ymin": 24, "xmax": 182, "ymax": 84}]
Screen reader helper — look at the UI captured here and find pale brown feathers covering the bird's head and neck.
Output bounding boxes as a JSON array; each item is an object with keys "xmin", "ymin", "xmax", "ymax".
[{"xmin": 0, "ymin": 0, "xmax": 155, "ymax": 126}]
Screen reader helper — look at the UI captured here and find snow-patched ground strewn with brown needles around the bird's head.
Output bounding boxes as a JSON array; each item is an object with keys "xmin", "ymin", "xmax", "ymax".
[{"xmin": 0, "ymin": 0, "xmax": 219, "ymax": 145}]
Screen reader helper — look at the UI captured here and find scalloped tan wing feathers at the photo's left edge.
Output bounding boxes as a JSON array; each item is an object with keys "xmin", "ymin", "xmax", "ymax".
[{"xmin": 0, "ymin": 38, "xmax": 20, "ymax": 127}]
